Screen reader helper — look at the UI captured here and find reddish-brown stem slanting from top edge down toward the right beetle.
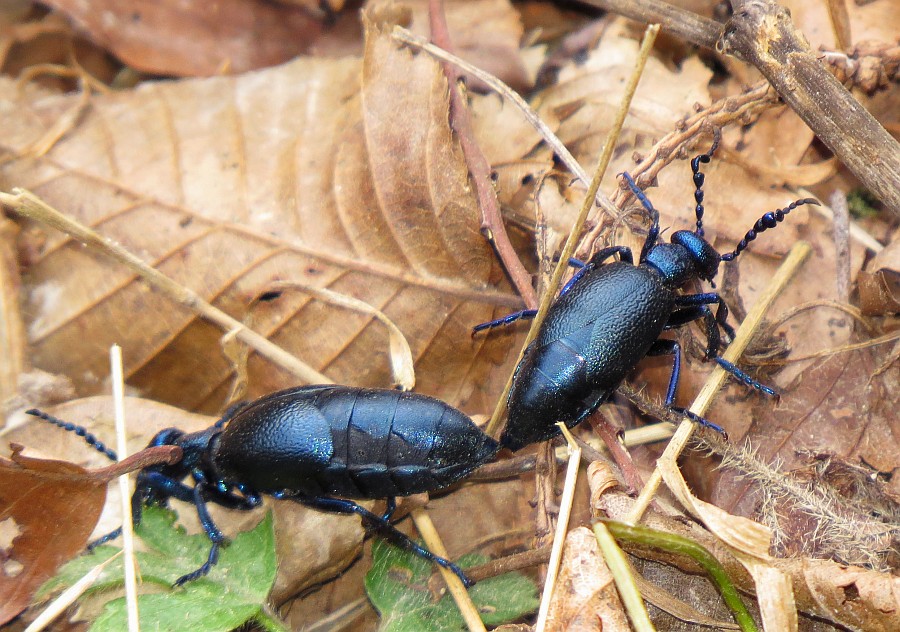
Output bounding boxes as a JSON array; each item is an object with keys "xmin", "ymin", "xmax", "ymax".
[{"xmin": 428, "ymin": 0, "xmax": 537, "ymax": 309}]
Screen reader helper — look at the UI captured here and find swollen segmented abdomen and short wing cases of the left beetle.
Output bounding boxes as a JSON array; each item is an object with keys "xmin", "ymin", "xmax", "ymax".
[{"xmin": 215, "ymin": 386, "xmax": 498, "ymax": 498}]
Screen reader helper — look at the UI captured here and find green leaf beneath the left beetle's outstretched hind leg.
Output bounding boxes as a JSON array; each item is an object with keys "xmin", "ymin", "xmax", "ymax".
[{"xmin": 365, "ymin": 540, "xmax": 538, "ymax": 632}]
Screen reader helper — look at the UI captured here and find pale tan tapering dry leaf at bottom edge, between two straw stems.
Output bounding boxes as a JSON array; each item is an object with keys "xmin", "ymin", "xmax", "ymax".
[{"xmin": 546, "ymin": 527, "xmax": 631, "ymax": 632}]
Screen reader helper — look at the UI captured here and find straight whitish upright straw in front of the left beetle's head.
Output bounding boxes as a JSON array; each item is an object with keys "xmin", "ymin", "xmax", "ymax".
[{"xmin": 109, "ymin": 345, "xmax": 140, "ymax": 632}]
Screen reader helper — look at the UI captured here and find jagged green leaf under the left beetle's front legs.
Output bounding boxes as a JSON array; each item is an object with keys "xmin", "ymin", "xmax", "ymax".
[{"xmin": 41, "ymin": 507, "xmax": 280, "ymax": 632}]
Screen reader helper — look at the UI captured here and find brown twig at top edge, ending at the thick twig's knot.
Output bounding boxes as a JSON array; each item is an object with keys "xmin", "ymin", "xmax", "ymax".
[{"xmin": 579, "ymin": 0, "xmax": 722, "ymax": 49}]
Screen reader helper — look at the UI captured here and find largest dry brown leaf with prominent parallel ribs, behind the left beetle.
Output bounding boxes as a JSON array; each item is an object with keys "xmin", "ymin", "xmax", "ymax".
[{"xmin": 0, "ymin": 12, "xmax": 520, "ymax": 409}]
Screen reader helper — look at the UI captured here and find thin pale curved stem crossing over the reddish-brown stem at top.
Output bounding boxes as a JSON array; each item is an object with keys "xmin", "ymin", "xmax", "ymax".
[{"xmin": 391, "ymin": 26, "xmax": 618, "ymax": 216}]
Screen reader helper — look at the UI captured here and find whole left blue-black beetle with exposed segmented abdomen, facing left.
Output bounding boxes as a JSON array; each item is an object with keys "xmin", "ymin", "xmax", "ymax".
[{"xmin": 27, "ymin": 386, "xmax": 499, "ymax": 586}]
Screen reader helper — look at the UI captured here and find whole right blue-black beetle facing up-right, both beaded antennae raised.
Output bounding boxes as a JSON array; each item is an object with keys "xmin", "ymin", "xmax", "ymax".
[{"xmin": 473, "ymin": 137, "xmax": 818, "ymax": 450}]
